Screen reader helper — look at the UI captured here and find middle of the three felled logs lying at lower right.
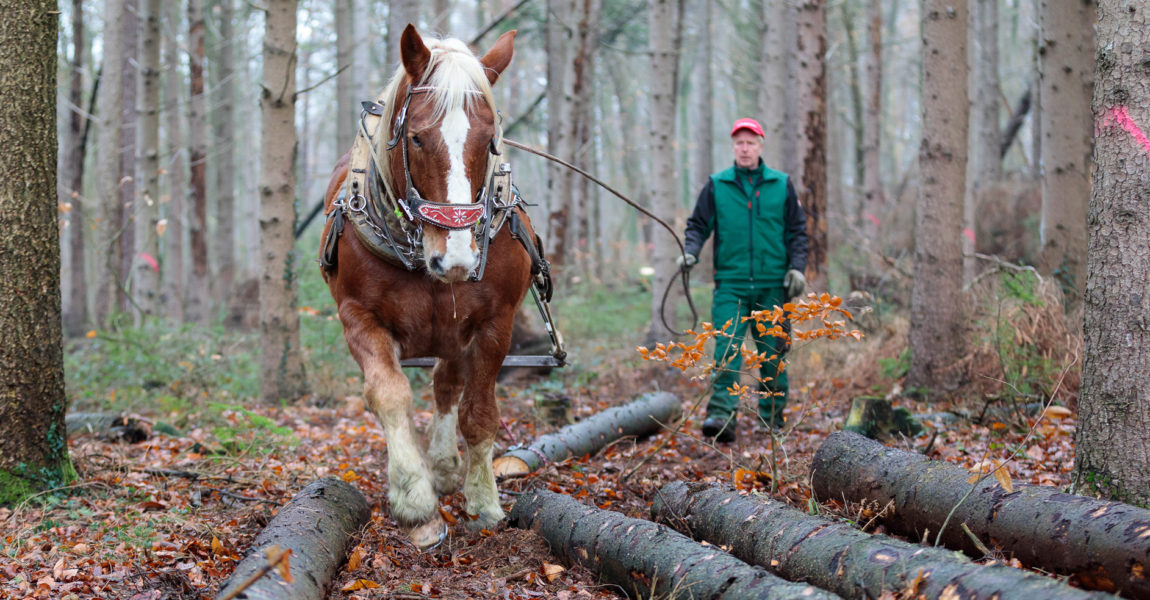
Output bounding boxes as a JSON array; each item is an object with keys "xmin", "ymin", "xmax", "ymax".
[{"xmin": 651, "ymin": 482, "xmax": 1111, "ymax": 600}]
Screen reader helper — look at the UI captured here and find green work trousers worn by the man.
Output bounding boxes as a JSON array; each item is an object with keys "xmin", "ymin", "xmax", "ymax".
[{"xmin": 707, "ymin": 282, "xmax": 790, "ymax": 428}]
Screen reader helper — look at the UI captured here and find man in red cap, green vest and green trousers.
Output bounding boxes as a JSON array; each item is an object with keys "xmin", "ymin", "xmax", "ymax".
[{"xmin": 679, "ymin": 118, "xmax": 807, "ymax": 443}]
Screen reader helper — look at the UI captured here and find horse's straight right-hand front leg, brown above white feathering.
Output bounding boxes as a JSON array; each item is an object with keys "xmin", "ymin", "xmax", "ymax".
[{"xmin": 459, "ymin": 356, "xmax": 504, "ymax": 529}]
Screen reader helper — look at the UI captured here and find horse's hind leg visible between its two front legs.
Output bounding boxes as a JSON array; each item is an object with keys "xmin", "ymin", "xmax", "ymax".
[{"xmin": 428, "ymin": 361, "xmax": 463, "ymax": 494}]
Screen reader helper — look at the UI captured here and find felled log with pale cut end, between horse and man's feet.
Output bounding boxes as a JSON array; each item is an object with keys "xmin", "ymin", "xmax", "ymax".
[{"xmin": 492, "ymin": 392, "xmax": 683, "ymax": 476}]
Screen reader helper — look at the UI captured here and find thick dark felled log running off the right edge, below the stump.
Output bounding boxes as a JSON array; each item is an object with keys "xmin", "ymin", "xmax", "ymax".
[{"xmin": 811, "ymin": 431, "xmax": 1150, "ymax": 598}]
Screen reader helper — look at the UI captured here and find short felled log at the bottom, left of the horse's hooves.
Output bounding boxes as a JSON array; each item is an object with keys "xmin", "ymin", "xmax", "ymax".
[{"xmin": 216, "ymin": 477, "xmax": 371, "ymax": 600}]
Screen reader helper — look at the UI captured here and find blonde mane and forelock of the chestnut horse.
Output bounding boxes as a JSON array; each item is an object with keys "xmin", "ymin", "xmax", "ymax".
[{"xmin": 375, "ymin": 37, "xmax": 503, "ymax": 203}]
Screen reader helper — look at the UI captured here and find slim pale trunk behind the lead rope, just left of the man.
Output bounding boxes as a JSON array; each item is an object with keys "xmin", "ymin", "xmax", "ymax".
[{"xmin": 645, "ymin": 0, "xmax": 682, "ymax": 346}]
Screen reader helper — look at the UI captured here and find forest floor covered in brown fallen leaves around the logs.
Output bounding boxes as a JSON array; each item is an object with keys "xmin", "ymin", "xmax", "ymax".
[{"xmin": 0, "ymin": 340, "xmax": 1074, "ymax": 600}]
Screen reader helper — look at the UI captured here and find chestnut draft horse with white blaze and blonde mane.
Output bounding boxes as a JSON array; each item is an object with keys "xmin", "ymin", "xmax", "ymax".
[{"xmin": 321, "ymin": 25, "xmax": 535, "ymax": 547}]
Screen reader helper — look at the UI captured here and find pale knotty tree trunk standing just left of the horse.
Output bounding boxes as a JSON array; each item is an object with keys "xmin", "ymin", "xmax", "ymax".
[{"xmin": 260, "ymin": 0, "xmax": 307, "ymax": 403}]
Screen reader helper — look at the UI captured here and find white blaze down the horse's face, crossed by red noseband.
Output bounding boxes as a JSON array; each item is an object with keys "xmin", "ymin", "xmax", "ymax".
[{"xmin": 432, "ymin": 107, "xmax": 478, "ymax": 280}]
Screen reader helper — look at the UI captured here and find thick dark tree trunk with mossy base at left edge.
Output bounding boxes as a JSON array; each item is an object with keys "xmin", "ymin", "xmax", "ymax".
[{"xmin": 0, "ymin": 0, "xmax": 74, "ymax": 506}]
